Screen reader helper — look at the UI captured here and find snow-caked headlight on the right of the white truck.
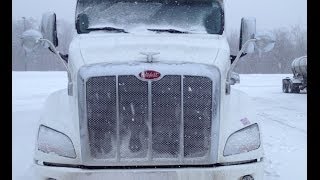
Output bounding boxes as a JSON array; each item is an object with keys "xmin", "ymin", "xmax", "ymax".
[{"xmin": 223, "ymin": 124, "xmax": 260, "ymax": 156}]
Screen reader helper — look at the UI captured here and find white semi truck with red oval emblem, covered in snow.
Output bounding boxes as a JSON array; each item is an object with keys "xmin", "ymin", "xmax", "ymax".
[{"xmin": 23, "ymin": 0, "xmax": 274, "ymax": 180}]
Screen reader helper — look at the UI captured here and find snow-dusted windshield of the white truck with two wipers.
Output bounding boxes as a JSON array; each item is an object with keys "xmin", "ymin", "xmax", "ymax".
[{"xmin": 76, "ymin": 0, "xmax": 224, "ymax": 34}]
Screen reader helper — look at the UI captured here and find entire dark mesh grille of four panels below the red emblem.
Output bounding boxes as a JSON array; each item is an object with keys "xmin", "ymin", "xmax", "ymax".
[{"xmin": 79, "ymin": 63, "xmax": 217, "ymax": 165}]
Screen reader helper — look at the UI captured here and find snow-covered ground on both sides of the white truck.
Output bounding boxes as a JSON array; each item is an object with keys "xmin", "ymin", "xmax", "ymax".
[{"xmin": 12, "ymin": 72, "xmax": 307, "ymax": 180}]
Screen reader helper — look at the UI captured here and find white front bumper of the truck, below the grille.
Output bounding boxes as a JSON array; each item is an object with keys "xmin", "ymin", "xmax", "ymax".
[{"xmin": 33, "ymin": 161, "xmax": 263, "ymax": 180}]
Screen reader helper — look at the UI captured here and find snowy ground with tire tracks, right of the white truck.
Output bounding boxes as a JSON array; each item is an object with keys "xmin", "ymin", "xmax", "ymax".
[{"xmin": 235, "ymin": 74, "xmax": 307, "ymax": 180}]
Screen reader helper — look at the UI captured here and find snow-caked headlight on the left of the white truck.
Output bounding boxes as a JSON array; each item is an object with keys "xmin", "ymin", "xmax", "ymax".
[{"xmin": 38, "ymin": 125, "xmax": 76, "ymax": 158}]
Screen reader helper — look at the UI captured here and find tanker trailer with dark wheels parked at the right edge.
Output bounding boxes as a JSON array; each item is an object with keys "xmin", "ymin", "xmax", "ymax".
[{"xmin": 282, "ymin": 56, "xmax": 308, "ymax": 93}]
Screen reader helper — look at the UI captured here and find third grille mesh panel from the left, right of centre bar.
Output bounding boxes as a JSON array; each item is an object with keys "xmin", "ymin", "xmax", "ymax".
[{"xmin": 152, "ymin": 76, "xmax": 181, "ymax": 158}]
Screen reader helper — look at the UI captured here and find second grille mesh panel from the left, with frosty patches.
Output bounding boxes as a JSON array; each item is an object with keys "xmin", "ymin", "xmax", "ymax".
[{"xmin": 118, "ymin": 76, "xmax": 149, "ymax": 158}]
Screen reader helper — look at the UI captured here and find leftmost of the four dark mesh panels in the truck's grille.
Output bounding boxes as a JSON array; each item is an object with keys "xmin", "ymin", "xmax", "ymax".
[{"xmin": 87, "ymin": 77, "xmax": 117, "ymax": 158}]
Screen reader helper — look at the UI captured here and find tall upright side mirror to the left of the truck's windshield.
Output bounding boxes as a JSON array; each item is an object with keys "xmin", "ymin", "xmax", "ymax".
[{"xmin": 40, "ymin": 12, "xmax": 58, "ymax": 47}]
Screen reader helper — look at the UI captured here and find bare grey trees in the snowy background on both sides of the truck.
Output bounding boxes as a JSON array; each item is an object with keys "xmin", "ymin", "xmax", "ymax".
[{"xmin": 12, "ymin": 18, "xmax": 307, "ymax": 74}]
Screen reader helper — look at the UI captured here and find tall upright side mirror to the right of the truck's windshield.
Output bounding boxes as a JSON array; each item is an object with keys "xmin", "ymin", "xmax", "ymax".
[{"xmin": 239, "ymin": 17, "xmax": 256, "ymax": 53}]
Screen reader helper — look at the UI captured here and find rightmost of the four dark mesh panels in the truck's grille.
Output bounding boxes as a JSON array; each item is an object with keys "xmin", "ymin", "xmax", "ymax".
[{"xmin": 183, "ymin": 76, "xmax": 212, "ymax": 157}]
